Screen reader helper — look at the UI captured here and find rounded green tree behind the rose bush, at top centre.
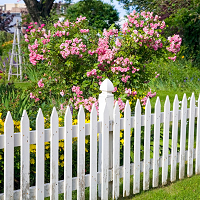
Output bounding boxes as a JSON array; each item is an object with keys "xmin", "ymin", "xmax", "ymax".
[{"xmin": 65, "ymin": 0, "xmax": 119, "ymax": 30}]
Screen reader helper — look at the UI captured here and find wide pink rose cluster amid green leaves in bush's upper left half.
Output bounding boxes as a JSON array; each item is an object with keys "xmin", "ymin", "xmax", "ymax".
[{"xmin": 60, "ymin": 38, "xmax": 86, "ymax": 59}]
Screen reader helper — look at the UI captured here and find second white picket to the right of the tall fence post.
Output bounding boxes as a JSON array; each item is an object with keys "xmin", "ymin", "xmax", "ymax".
[{"xmin": 123, "ymin": 100, "xmax": 131, "ymax": 197}]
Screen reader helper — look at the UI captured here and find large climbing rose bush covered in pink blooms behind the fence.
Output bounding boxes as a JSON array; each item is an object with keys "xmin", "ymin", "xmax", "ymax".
[{"xmin": 22, "ymin": 11, "xmax": 182, "ymax": 114}]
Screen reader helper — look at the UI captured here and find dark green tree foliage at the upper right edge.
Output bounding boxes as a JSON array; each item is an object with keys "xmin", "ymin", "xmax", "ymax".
[{"xmin": 165, "ymin": 1, "xmax": 200, "ymax": 67}]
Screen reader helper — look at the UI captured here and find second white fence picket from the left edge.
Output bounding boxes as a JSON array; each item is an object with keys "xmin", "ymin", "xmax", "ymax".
[{"xmin": 20, "ymin": 110, "xmax": 30, "ymax": 200}]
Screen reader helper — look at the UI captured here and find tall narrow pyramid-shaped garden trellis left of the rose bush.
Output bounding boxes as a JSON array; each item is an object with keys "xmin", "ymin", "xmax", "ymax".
[{"xmin": 8, "ymin": 20, "xmax": 22, "ymax": 81}]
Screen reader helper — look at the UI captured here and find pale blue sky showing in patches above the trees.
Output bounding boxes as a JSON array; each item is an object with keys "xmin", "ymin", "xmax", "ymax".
[{"xmin": 0, "ymin": 0, "xmax": 126, "ymax": 18}]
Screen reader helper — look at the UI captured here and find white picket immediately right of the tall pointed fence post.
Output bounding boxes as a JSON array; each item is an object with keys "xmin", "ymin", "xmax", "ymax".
[{"xmin": 113, "ymin": 102, "xmax": 120, "ymax": 199}]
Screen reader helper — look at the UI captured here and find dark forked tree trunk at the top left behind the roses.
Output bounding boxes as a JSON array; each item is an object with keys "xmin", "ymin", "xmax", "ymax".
[{"xmin": 24, "ymin": 0, "xmax": 54, "ymax": 26}]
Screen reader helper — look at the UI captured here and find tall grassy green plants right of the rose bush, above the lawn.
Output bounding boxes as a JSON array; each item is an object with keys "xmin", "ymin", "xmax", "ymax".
[{"xmin": 148, "ymin": 56, "xmax": 200, "ymax": 92}]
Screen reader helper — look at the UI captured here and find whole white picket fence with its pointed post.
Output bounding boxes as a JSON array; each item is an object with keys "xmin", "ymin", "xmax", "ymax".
[{"xmin": 0, "ymin": 79, "xmax": 200, "ymax": 200}]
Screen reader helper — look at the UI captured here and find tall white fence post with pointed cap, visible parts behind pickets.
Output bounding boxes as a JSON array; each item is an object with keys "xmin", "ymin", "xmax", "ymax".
[{"xmin": 98, "ymin": 79, "xmax": 114, "ymax": 197}]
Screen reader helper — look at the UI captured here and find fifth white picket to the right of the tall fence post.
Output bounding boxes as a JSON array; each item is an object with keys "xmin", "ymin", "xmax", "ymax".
[{"xmin": 152, "ymin": 97, "xmax": 160, "ymax": 187}]
